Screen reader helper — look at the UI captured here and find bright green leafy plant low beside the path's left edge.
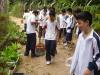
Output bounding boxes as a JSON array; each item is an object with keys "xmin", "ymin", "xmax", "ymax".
[{"xmin": 1, "ymin": 43, "xmax": 19, "ymax": 62}]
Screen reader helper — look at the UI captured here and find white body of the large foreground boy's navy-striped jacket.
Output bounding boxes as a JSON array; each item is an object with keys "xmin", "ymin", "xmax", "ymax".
[{"xmin": 70, "ymin": 30, "xmax": 100, "ymax": 75}]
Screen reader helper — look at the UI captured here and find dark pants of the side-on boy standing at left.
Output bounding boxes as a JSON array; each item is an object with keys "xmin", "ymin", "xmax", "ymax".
[{"xmin": 25, "ymin": 33, "xmax": 36, "ymax": 56}]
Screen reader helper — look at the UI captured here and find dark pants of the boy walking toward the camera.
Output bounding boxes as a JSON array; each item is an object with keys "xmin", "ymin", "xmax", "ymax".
[{"xmin": 45, "ymin": 40, "xmax": 56, "ymax": 61}]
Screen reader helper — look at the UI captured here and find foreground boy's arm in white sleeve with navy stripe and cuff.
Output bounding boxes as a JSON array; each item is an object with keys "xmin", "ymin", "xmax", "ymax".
[{"xmin": 88, "ymin": 33, "xmax": 100, "ymax": 71}]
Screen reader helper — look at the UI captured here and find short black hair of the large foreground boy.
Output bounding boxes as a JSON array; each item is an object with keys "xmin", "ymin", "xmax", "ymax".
[{"xmin": 75, "ymin": 11, "xmax": 92, "ymax": 26}]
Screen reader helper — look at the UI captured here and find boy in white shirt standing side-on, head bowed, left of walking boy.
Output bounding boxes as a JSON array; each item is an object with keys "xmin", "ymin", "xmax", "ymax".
[{"xmin": 24, "ymin": 10, "xmax": 38, "ymax": 57}]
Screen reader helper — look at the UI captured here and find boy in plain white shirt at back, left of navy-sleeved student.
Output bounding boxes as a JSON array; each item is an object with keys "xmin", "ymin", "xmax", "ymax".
[{"xmin": 58, "ymin": 9, "xmax": 67, "ymax": 42}]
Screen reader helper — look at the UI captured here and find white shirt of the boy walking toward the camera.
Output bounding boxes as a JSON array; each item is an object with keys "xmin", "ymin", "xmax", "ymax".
[{"xmin": 45, "ymin": 19, "xmax": 59, "ymax": 40}]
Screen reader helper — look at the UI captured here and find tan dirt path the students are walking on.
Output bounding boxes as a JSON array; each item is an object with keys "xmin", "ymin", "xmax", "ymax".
[{"xmin": 11, "ymin": 17, "xmax": 75, "ymax": 75}]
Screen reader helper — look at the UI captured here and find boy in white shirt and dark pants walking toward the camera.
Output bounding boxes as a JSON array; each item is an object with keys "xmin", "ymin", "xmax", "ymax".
[{"xmin": 44, "ymin": 11, "xmax": 59, "ymax": 65}]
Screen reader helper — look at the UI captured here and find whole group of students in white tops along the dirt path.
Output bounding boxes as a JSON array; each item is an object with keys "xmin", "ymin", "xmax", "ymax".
[{"xmin": 23, "ymin": 7, "xmax": 100, "ymax": 75}]
